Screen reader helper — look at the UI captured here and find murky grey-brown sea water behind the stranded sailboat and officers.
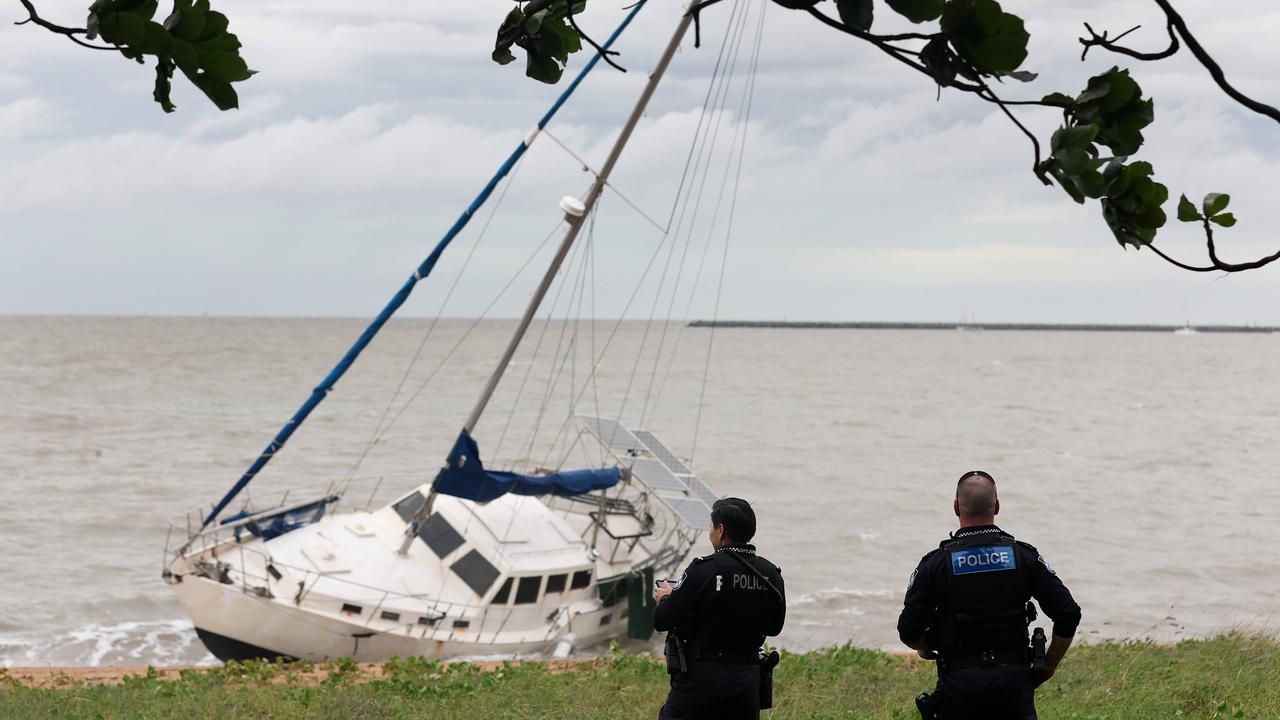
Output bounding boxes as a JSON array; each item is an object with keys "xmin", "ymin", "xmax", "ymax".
[{"xmin": 0, "ymin": 318, "xmax": 1280, "ymax": 665}]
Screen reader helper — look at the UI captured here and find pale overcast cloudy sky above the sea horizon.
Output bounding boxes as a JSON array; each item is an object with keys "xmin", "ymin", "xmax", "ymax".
[{"xmin": 0, "ymin": 0, "xmax": 1280, "ymax": 325}]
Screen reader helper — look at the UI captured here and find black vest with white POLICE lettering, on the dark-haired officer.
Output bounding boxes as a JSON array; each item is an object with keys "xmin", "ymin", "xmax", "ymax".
[{"xmin": 680, "ymin": 550, "xmax": 782, "ymax": 652}]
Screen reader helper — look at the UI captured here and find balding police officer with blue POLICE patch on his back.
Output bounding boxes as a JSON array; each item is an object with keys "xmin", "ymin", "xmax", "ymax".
[{"xmin": 897, "ymin": 470, "xmax": 1080, "ymax": 720}]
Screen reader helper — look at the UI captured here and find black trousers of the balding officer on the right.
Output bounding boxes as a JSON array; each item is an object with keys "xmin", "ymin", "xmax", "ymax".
[{"xmin": 938, "ymin": 665, "xmax": 1036, "ymax": 720}]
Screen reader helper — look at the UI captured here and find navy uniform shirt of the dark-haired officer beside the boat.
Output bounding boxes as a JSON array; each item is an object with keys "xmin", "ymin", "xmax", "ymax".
[{"xmin": 653, "ymin": 543, "xmax": 786, "ymax": 652}]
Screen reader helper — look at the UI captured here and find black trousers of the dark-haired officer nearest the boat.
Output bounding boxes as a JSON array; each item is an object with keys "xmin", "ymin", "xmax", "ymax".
[{"xmin": 658, "ymin": 662, "xmax": 760, "ymax": 720}]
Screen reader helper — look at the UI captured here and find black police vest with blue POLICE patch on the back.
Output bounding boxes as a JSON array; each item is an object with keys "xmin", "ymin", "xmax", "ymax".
[{"xmin": 934, "ymin": 530, "xmax": 1030, "ymax": 659}]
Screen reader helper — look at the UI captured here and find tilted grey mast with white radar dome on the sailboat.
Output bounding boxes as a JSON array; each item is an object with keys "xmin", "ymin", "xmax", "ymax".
[{"xmin": 401, "ymin": 12, "xmax": 694, "ymax": 532}]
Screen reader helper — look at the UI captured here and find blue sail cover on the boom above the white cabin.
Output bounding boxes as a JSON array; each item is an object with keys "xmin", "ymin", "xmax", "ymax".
[{"xmin": 431, "ymin": 430, "xmax": 622, "ymax": 502}]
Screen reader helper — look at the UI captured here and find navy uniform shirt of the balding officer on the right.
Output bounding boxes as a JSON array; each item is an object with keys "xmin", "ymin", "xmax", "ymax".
[{"xmin": 897, "ymin": 525, "xmax": 1080, "ymax": 657}]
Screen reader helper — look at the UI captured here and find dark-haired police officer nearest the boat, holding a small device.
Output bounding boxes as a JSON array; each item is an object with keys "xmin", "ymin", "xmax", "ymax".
[{"xmin": 653, "ymin": 497, "xmax": 786, "ymax": 720}]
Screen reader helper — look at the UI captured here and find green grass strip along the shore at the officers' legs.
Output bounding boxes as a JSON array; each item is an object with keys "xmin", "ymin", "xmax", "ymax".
[{"xmin": 0, "ymin": 634, "xmax": 1280, "ymax": 720}]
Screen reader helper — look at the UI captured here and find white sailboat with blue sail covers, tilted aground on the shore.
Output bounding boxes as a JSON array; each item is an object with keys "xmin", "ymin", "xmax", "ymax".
[{"xmin": 163, "ymin": 0, "xmax": 763, "ymax": 661}]
